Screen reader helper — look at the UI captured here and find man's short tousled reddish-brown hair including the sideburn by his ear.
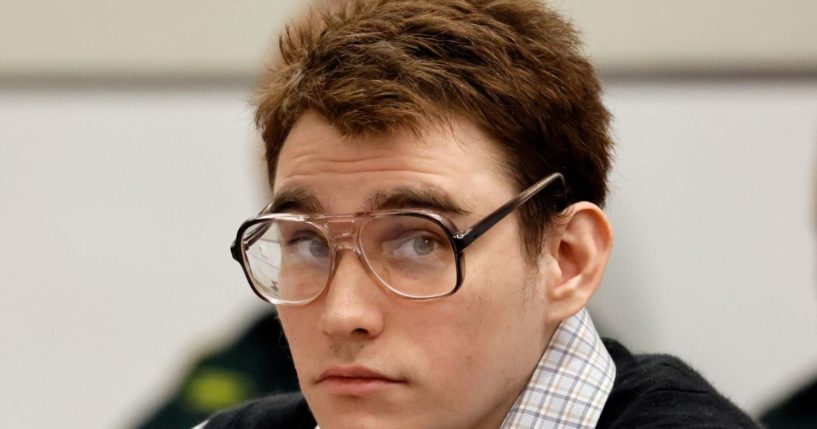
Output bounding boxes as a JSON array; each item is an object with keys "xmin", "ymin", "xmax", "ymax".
[{"xmin": 256, "ymin": 0, "xmax": 612, "ymax": 260}]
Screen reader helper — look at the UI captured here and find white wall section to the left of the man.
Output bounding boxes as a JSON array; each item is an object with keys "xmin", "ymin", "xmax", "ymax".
[{"xmin": 0, "ymin": 88, "xmax": 263, "ymax": 429}]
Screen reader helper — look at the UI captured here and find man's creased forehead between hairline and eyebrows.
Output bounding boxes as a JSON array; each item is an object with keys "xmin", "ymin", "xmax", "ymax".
[{"xmin": 273, "ymin": 113, "xmax": 513, "ymax": 211}]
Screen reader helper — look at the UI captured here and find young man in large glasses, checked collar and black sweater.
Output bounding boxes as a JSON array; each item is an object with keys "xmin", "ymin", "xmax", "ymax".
[{"xmin": 204, "ymin": 0, "xmax": 754, "ymax": 429}]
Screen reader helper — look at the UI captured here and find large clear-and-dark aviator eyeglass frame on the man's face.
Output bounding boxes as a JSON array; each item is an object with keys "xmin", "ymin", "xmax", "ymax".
[{"xmin": 230, "ymin": 173, "xmax": 566, "ymax": 305}]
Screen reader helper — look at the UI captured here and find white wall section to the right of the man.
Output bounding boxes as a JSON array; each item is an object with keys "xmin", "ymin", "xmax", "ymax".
[{"xmin": 593, "ymin": 81, "xmax": 817, "ymax": 411}]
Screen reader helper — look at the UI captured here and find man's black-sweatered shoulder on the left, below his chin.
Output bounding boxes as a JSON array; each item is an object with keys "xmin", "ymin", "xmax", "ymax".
[{"xmin": 199, "ymin": 393, "xmax": 316, "ymax": 429}]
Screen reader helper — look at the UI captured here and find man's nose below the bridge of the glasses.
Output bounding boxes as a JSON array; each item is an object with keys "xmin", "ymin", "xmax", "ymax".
[{"xmin": 319, "ymin": 251, "xmax": 388, "ymax": 339}]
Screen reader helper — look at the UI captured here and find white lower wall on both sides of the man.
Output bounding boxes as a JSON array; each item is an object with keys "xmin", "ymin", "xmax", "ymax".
[{"xmin": 0, "ymin": 81, "xmax": 817, "ymax": 428}]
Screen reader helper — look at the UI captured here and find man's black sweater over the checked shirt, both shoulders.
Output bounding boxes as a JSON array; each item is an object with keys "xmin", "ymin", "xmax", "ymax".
[{"xmin": 205, "ymin": 339, "xmax": 758, "ymax": 429}]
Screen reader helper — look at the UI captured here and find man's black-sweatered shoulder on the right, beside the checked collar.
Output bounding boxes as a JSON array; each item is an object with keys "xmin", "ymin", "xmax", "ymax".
[{"xmin": 598, "ymin": 339, "xmax": 758, "ymax": 429}]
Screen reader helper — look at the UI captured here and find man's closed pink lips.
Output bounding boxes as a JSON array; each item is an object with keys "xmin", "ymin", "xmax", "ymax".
[{"xmin": 315, "ymin": 366, "xmax": 406, "ymax": 396}]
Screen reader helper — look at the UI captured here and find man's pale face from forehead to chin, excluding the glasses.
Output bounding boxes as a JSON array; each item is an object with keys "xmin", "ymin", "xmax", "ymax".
[{"xmin": 274, "ymin": 113, "xmax": 553, "ymax": 429}]
